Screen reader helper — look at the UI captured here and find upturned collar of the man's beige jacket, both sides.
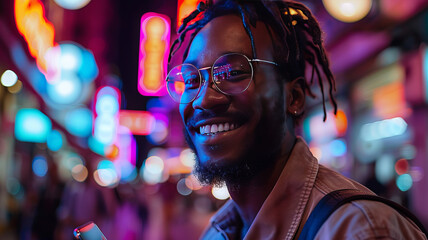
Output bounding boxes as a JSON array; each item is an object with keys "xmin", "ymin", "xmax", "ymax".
[{"xmin": 211, "ymin": 138, "xmax": 319, "ymax": 239}]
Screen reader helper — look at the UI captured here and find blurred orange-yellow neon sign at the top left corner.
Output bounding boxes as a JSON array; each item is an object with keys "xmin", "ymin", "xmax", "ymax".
[{"xmin": 14, "ymin": 0, "xmax": 55, "ymax": 72}]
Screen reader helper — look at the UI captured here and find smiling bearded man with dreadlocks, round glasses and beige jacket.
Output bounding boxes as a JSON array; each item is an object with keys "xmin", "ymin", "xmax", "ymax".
[{"xmin": 167, "ymin": 0, "xmax": 425, "ymax": 239}]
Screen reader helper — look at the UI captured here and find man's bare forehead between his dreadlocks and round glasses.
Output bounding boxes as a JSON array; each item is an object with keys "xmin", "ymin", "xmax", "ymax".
[{"xmin": 185, "ymin": 15, "xmax": 273, "ymax": 67}]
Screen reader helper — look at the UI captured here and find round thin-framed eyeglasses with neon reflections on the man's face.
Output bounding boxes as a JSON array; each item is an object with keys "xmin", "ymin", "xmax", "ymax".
[{"xmin": 166, "ymin": 53, "xmax": 278, "ymax": 103}]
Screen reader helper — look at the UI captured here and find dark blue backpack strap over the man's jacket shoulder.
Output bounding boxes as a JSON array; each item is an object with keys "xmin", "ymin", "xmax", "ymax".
[{"xmin": 299, "ymin": 189, "xmax": 428, "ymax": 240}]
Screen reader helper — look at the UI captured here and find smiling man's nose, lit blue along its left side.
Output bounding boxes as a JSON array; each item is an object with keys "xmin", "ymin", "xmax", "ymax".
[{"xmin": 192, "ymin": 69, "xmax": 230, "ymax": 111}]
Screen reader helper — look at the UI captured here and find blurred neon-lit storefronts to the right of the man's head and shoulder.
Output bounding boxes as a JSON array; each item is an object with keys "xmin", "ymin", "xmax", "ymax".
[{"xmin": 302, "ymin": 1, "xmax": 428, "ymax": 223}]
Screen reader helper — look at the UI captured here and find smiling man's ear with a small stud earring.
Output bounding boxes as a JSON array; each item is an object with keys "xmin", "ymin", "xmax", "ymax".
[{"xmin": 286, "ymin": 77, "xmax": 305, "ymax": 116}]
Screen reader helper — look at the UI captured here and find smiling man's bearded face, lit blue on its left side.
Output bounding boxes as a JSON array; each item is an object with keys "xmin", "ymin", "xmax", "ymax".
[{"xmin": 180, "ymin": 15, "xmax": 287, "ymax": 184}]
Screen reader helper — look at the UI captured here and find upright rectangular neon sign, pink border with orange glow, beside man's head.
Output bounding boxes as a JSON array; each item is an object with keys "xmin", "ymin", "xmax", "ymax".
[{"xmin": 138, "ymin": 13, "xmax": 171, "ymax": 96}]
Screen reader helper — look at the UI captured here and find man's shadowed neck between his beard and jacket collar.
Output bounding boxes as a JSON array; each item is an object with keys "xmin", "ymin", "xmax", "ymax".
[{"xmin": 226, "ymin": 136, "xmax": 296, "ymax": 232}]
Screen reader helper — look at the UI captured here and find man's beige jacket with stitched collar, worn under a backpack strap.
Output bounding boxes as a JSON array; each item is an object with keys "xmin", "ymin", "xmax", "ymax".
[{"xmin": 201, "ymin": 138, "xmax": 426, "ymax": 240}]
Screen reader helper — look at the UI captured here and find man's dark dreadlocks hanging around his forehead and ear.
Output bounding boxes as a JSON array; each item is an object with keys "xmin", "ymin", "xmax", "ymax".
[{"xmin": 168, "ymin": 0, "xmax": 337, "ymax": 121}]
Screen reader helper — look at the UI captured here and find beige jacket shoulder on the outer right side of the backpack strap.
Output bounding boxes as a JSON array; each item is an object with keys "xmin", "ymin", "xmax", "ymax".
[{"xmin": 316, "ymin": 200, "xmax": 426, "ymax": 239}]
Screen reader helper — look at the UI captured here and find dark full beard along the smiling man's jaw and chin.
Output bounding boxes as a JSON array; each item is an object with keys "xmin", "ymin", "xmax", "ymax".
[{"xmin": 184, "ymin": 96, "xmax": 285, "ymax": 188}]
